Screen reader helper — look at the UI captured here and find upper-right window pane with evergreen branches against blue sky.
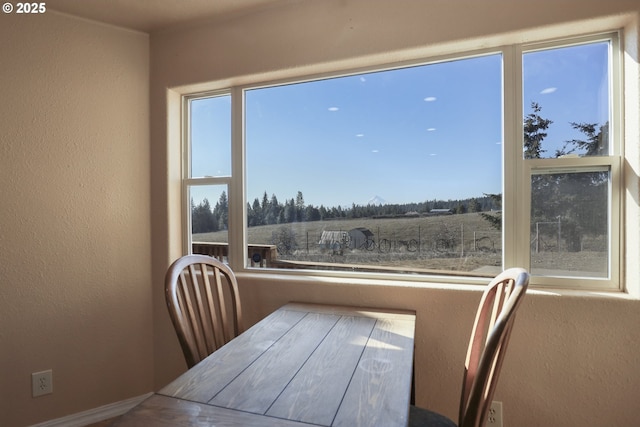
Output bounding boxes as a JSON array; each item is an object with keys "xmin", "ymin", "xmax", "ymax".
[{"xmin": 523, "ymin": 42, "xmax": 610, "ymax": 159}]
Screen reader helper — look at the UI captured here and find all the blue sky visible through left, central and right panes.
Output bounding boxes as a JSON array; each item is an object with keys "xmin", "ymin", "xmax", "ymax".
[{"xmin": 192, "ymin": 44, "xmax": 608, "ymax": 207}]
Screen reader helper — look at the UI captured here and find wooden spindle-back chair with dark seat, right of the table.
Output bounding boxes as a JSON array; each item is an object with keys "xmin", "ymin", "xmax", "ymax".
[{"xmin": 409, "ymin": 268, "xmax": 529, "ymax": 427}]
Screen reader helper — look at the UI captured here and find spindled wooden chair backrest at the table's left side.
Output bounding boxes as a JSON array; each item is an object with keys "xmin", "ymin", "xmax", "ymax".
[{"xmin": 165, "ymin": 255, "xmax": 242, "ymax": 368}]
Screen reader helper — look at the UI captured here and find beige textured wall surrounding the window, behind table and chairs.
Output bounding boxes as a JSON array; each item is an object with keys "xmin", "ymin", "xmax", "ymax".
[{"xmin": 151, "ymin": 0, "xmax": 640, "ymax": 427}]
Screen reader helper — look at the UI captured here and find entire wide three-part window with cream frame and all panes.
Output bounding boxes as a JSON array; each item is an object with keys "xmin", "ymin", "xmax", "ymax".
[{"xmin": 184, "ymin": 34, "xmax": 621, "ymax": 289}]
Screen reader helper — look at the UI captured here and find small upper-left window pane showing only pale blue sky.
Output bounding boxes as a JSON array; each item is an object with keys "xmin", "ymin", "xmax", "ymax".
[{"xmin": 190, "ymin": 95, "xmax": 231, "ymax": 178}]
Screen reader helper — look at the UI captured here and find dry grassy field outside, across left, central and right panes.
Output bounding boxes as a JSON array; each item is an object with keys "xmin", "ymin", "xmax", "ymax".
[{"xmin": 193, "ymin": 213, "xmax": 607, "ymax": 277}]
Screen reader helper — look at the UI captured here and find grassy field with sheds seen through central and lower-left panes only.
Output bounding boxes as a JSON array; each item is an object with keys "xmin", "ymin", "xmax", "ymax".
[{"xmin": 193, "ymin": 207, "xmax": 502, "ymax": 271}]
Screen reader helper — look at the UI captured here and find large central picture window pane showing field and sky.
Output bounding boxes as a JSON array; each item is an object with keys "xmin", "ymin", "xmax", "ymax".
[{"xmin": 245, "ymin": 55, "xmax": 502, "ymax": 275}]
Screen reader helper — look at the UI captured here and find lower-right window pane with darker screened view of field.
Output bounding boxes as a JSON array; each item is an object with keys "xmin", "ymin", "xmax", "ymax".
[{"xmin": 531, "ymin": 171, "xmax": 610, "ymax": 278}]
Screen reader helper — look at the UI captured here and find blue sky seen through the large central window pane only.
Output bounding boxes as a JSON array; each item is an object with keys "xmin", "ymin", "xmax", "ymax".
[{"xmin": 246, "ymin": 55, "xmax": 502, "ymax": 206}]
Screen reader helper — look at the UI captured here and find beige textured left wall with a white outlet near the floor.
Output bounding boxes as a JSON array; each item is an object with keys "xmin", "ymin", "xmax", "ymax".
[{"xmin": 0, "ymin": 11, "xmax": 153, "ymax": 427}]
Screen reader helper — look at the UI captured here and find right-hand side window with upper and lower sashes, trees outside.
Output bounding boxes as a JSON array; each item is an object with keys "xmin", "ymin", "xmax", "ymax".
[{"xmin": 520, "ymin": 35, "xmax": 621, "ymax": 286}]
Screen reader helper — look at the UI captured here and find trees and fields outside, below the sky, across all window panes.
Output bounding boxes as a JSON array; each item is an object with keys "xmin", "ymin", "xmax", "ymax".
[{"xmin": 191, "ymin": 103, "xmax": 610, "ymax": 277}]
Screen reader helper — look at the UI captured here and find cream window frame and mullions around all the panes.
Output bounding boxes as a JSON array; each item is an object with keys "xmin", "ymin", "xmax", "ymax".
[{"xmin": 181, "ymin": 30, "xmax": 625, "ymax": 291}]
